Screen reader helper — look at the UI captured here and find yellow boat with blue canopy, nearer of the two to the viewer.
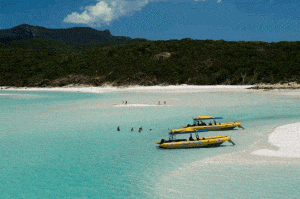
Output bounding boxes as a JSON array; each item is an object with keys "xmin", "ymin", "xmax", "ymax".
[{"xmin": 157, "ymin": 130, "xmax": 235, "ymax": 149}]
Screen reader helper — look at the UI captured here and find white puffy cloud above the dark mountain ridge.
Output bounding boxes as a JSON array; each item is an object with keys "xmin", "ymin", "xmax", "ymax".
[{"xmin": 64, "ymin": 0, "xmax": 161, "ymax": 27}]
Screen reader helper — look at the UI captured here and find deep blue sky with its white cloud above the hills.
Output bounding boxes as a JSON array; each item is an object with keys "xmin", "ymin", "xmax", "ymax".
[{"xmin": 0, "ymin": 0, "xmax": 300, "ymax": 42}]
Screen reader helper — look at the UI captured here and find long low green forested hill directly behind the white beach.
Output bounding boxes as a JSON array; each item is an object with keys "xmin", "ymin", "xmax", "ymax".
[{"xmin": 0, "ymin": 27, "xmax": 300, "ymax": 86}]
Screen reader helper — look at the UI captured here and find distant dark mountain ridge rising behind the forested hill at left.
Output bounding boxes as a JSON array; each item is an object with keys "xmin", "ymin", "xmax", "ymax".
[{"xmin": 0, "ymin": 24, "xmax": 147, "ymax": 52}]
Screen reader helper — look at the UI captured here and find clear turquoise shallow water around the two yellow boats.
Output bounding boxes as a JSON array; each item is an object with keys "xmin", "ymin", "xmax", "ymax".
[{"xmin": 0, "ymin": 90, "xmax": 300, "ymax": 199}]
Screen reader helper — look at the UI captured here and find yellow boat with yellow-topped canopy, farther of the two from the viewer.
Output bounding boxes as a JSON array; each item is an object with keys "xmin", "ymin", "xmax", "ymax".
[{"xmin": 171, "ymin": 116, "xmax": 244, "ymax": 133}]
